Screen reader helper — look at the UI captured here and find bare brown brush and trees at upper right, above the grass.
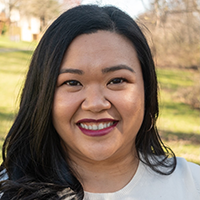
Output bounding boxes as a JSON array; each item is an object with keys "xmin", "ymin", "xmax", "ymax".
[{"xmin": 139, "ymin": 0, "xmax": 200, "ymax": 68}]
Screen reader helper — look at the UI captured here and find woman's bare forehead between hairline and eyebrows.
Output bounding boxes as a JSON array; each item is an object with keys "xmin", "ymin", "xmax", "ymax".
[{"xmin": 61, "ymin": 31, "xmax": 139, "ymax": 72}]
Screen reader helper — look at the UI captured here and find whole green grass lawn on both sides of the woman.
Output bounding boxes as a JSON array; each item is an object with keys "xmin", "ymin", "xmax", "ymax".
[{"xmin": 0, "ymin": 37, "xmax": 200, "ymax": 164}]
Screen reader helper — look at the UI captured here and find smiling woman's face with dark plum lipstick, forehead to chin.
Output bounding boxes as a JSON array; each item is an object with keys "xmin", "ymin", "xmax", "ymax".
[{"xmin": 53, "ymin": 31, "xmax": 144, "ymax": 162}]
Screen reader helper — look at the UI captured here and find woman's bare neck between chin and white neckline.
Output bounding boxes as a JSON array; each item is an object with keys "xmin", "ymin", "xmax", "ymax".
[{"xmin": 71, "ymin": 151, "xmax": 139, "ymax": 193}]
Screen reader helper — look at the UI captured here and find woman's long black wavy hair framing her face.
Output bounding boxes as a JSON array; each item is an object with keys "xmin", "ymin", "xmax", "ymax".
[{"xmin": 0, "ymin": 5, "xmax": 176, "ymax": 200}]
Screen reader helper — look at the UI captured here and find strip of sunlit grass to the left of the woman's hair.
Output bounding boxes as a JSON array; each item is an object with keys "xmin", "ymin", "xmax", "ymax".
[{"xmin": 0, "ymin": 37, "xmax": 34, "ymax": 160}]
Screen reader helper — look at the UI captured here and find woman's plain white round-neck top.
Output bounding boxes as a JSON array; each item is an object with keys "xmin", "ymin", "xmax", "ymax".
[{"xmin": 84, "ymin": 158, "xmax": 200, "ymax": 200}]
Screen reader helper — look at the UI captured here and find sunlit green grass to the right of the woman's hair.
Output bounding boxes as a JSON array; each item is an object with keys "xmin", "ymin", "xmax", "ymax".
[{"xmin": 157, "ymin": 69, "xmax": 200, "ymax": 164}]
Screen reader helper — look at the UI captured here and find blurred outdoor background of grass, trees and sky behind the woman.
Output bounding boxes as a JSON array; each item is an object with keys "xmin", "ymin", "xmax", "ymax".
[{"xmin": 0, "ymin": 0, "xmax": 200, "ymax": 164}]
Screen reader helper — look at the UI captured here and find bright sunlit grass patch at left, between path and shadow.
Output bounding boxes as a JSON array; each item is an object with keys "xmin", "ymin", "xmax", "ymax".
[{"xmin": 0, "ymin": 52, "xmax": 30, "ymax": 112}]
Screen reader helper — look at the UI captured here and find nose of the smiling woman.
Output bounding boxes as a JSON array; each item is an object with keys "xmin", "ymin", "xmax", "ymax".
[{"xmin": 81, "ymin": 86, "xmax": 111, "ymax": 112}]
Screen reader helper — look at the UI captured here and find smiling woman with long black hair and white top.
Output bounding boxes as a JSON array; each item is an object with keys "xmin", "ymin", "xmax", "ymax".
[{"xmin": 0, "ymin": 3, "xmax": 200, "ymax": 200}]
